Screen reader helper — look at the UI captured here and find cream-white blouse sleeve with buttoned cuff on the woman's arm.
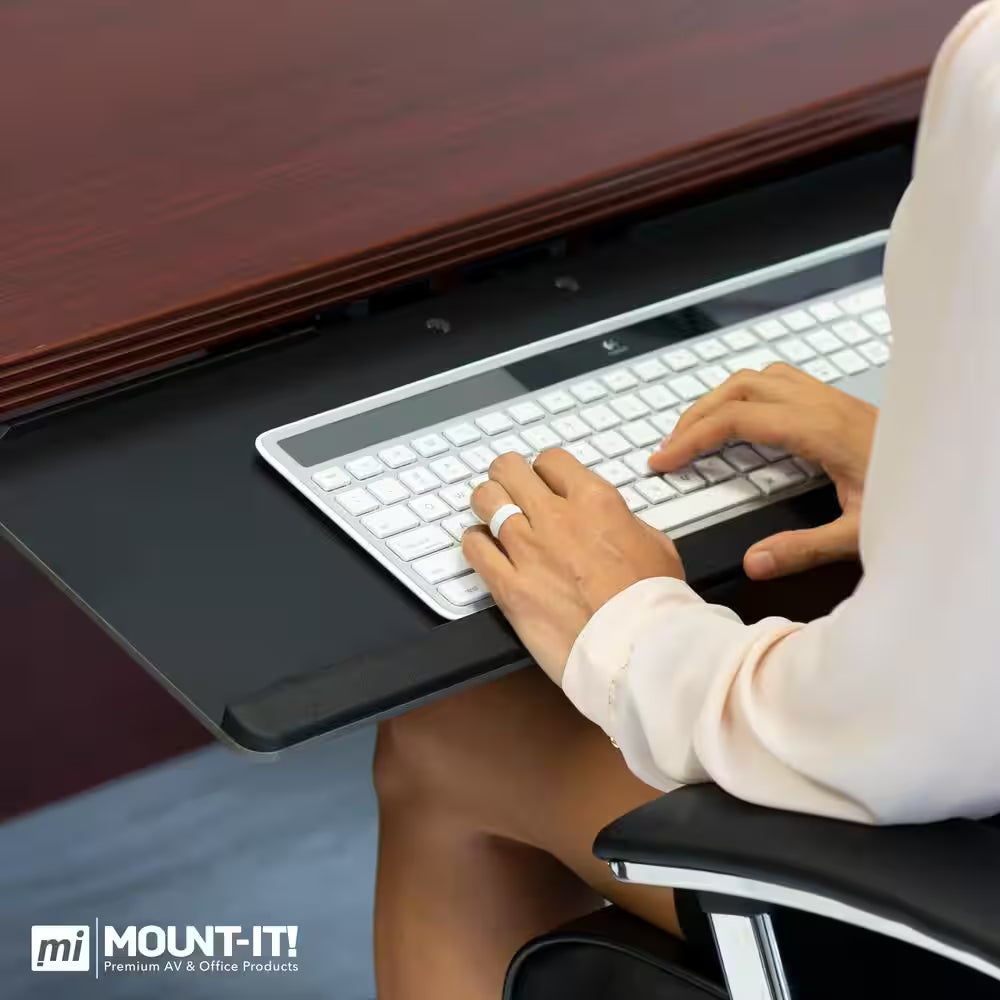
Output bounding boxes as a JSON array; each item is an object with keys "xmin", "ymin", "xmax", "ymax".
[{"xmin": 563, "ymin": 0, "xmax": 1000, "ymax": 823}]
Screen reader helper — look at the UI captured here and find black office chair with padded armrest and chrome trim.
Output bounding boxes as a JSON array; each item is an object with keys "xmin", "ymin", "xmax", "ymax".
[{"xmin": 504, "ymin": 788, "xmax": 1000, "ymax": 1000}]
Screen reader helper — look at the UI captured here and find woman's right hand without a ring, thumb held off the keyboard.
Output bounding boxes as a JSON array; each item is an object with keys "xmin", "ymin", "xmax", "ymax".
[{"xmin": 649, "ymin": 364, "xmax": 878, "ymax": 580}]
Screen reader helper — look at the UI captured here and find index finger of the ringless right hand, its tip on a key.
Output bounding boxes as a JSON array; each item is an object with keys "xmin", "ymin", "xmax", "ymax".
[{"xmin": 649, "ymin": 401, "xmax": 802, "ymax": 472}]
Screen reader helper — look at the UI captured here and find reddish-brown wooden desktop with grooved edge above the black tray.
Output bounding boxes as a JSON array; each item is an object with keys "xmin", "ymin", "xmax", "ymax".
[{"xmin": 0, "ymin": 0, "xmax": 970, "ymax": 417}]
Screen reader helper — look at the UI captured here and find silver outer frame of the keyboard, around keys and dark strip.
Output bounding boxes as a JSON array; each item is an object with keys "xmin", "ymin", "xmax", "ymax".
[{"xmin": 256, "ymin": 230, "xmax": 888, "ymax": 620}]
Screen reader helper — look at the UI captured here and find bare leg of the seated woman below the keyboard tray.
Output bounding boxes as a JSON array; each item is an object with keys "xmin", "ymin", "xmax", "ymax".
[{"xmin": 375, "ymin": 669, "xmax": 678, "ymax": 1000}]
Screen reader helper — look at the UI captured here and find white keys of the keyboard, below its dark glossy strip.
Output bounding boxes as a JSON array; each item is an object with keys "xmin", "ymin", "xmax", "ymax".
[{"xmin": 258, "ymin": 239, "xmax": 892, "ymax": 618}]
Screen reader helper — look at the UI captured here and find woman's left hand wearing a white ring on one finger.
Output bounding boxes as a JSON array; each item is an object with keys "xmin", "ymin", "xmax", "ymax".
[{"xmin": 462, "ymin": 448, "xmax": 684, "ymax": 683}]
